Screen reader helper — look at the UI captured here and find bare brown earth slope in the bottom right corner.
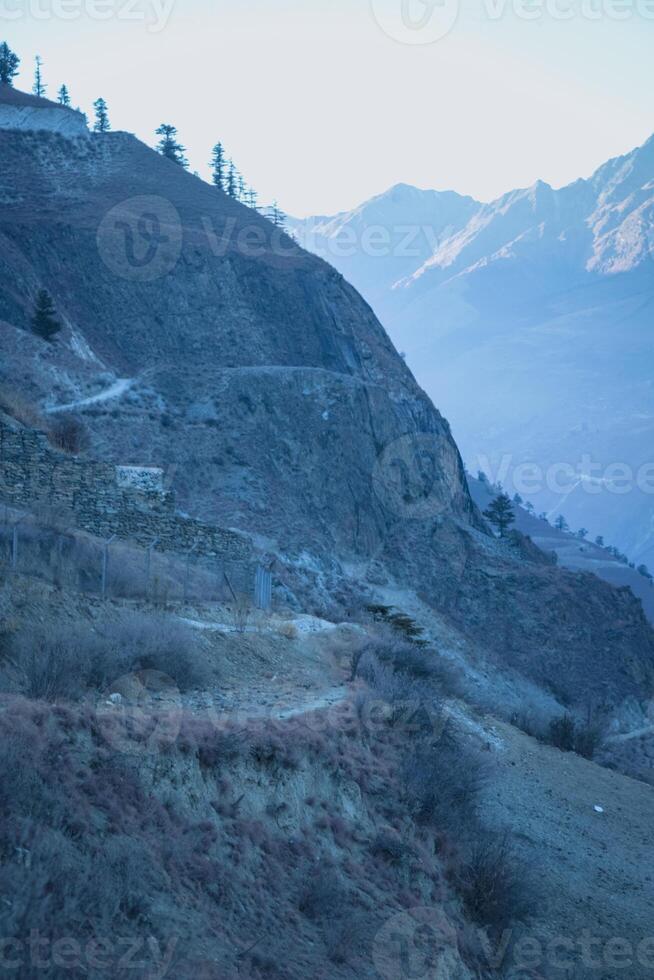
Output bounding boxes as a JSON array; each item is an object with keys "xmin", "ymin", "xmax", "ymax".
[{"xmin": 484, "ymin": 724, "xmax": 654, "ymax": 980}]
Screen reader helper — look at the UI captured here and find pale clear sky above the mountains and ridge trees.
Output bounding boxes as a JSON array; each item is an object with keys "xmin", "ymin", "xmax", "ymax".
[{"xmin": 5, "ymin": 0, "xmax": 654, "ymax": 216}]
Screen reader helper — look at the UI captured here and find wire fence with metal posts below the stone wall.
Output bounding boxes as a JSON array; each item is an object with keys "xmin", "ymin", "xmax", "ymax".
[{"xmin": 0, "ymin": 507, "xmax": 272, "ymax": 610}]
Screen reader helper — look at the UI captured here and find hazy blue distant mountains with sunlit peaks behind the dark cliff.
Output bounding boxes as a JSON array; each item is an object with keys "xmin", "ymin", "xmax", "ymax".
[{"xmin": 290, "ymin": 137, "xmax": 654, "ymax": 566}]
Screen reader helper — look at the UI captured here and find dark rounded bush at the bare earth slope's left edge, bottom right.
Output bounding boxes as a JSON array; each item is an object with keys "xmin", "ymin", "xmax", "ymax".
[{"xmin": 455, "ymin": 834, "xmax": 531, "ymax": 933}]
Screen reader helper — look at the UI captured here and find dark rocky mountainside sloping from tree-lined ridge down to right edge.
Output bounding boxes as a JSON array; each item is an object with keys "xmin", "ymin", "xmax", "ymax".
[{"xmin": 0, "ymin": 97, "xmax": 654, "ymax": 712}]
